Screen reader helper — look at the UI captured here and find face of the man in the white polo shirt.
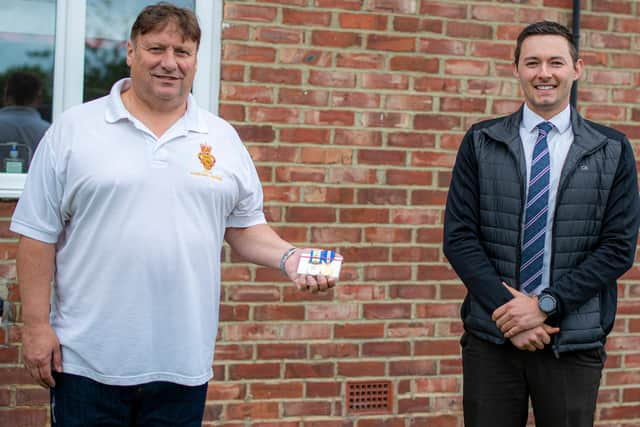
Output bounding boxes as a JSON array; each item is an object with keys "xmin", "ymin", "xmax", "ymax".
[{"xmin": 127, "ymin": 21, "xmax": 198, "ymax": 111}]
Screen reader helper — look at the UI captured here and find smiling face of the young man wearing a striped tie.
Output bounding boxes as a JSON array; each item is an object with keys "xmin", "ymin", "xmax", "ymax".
[{"xmin": 513, "ymin": 34, "xmax": 584, "ymax": 119}]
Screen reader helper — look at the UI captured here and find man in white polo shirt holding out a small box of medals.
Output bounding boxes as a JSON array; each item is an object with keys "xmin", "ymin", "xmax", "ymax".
[{"xmin": 11, "ymin": 3, "xmax": 335, "ymax": 427}]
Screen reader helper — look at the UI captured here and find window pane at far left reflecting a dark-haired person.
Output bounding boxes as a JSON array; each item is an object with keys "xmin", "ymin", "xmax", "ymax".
[{"xmin": 0, "ymin": 0, "xmax": 56, "ymax": 173}]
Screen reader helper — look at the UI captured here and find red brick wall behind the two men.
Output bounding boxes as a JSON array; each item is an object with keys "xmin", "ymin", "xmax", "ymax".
[{"xmin": 0, "ymin": 0, "xmax": 640, "ymax": 427}]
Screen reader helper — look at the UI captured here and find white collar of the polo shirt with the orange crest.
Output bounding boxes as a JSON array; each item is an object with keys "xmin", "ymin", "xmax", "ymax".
[{"xmin": 104, "ymin": 77, "xmax": 209, "ymax": 133}]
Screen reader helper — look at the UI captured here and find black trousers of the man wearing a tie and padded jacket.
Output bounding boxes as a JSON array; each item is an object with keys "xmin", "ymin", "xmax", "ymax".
[{"xmin": 460, "ymin": 333, "xmax": 606, "ymax": 427}]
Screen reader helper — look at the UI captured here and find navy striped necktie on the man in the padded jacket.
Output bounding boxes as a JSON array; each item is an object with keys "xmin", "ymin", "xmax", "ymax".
[{"xmin": 520, "ymin": 122, "xmax": 553, "ymax": 294}]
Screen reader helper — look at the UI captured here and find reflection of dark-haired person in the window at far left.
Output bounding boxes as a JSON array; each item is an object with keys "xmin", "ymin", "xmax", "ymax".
[{"xmin": 0, "ymin": 71, "xmax": 49, "ymax": 173}]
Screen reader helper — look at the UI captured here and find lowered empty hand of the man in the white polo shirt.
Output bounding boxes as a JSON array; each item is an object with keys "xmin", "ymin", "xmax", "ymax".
[{"xmin": 22, "ymin": 324, "xmax": 62, "ymax": 388}]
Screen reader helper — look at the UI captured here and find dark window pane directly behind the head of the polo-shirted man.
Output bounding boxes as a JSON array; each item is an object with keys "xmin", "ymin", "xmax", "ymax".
[{"xmin": 84, "ymin": 0, "xmax": 195, "ymax": 101}]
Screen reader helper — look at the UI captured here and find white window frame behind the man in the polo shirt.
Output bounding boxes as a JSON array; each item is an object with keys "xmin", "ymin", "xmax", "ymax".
[{"xmin": 0, "ymin": 0, "xmax": 223, "ymax": 199}]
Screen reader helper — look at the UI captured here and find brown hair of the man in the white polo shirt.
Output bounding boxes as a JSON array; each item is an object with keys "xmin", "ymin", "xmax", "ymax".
[{"xmin": 130, "ymin": 2, "xmax": 202, "ymax": 46}]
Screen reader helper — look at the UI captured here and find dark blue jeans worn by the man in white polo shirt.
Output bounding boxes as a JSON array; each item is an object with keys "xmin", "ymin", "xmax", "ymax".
[{"xmin": 51, "ymin": 373, "xmax": 207, "ymax": 427}]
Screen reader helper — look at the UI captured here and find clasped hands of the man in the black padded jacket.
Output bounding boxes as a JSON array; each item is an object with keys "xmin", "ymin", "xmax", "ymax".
[{"xmin": 491, "ymin": 283, "xmax": 560, "ymax": 351}]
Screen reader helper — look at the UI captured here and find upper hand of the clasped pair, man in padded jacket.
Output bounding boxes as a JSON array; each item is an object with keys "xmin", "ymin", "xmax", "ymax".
[{"xmin": 491, "ymin": 283, "xmax": 547, "ymax": 338}]
